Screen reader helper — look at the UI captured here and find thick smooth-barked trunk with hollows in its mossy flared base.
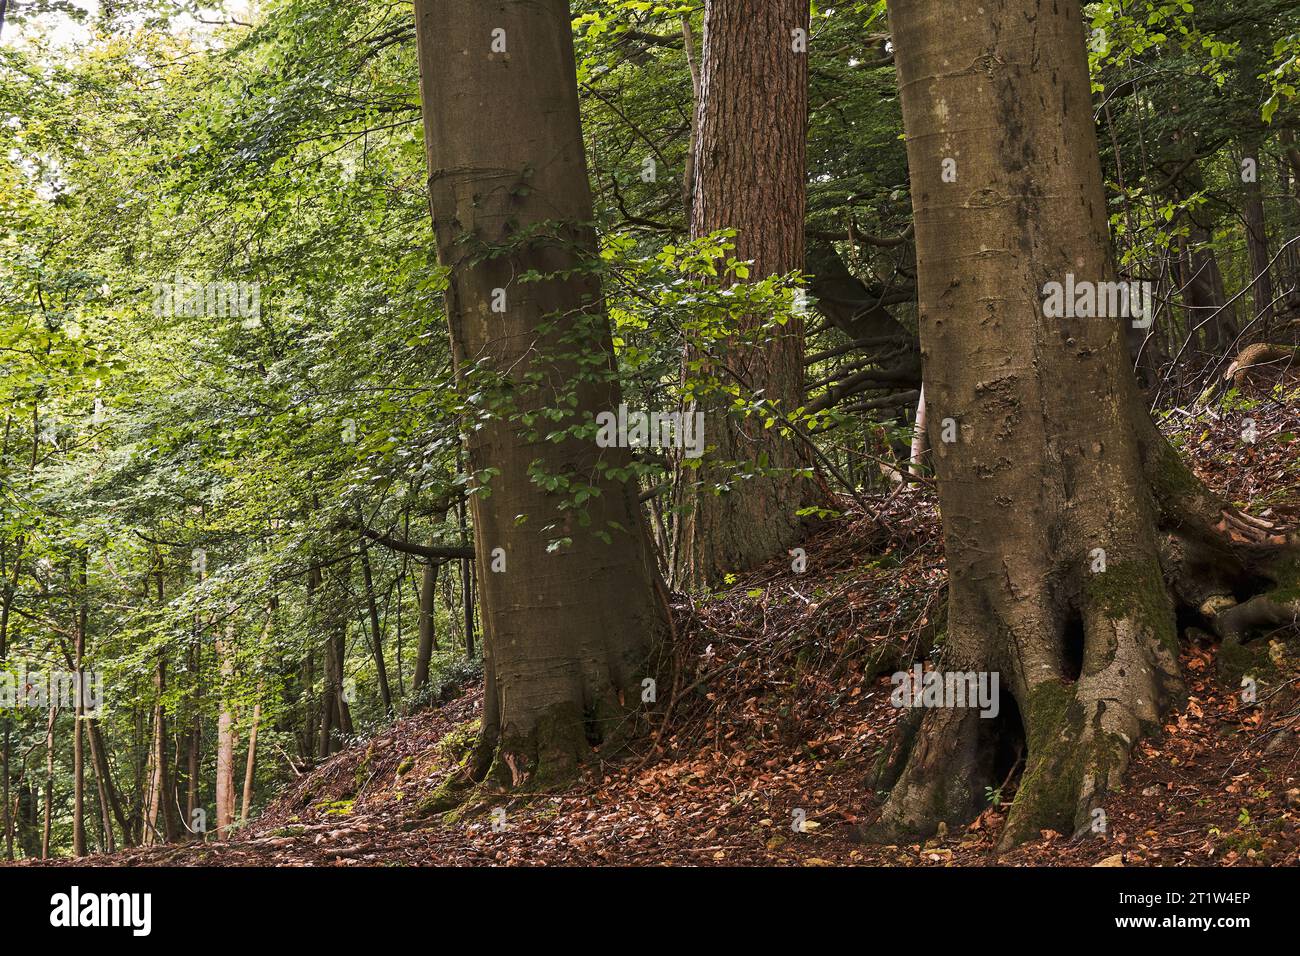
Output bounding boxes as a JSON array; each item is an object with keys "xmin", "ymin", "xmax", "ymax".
[{"xmin": 868, "ymin": 0, "xmax": 1300, "ymax": 847}]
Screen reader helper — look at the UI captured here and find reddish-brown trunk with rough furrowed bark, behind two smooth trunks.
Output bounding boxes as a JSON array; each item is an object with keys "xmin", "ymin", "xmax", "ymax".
[{"xmin": 684, "ymin": 0, "xmax": 814, "ymax": 587}]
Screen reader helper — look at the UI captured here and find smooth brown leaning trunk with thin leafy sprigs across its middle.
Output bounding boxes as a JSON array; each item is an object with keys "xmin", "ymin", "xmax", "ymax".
[{"xmin": 416, "ymin": 0, "xmax": 666, "ymax": 784}]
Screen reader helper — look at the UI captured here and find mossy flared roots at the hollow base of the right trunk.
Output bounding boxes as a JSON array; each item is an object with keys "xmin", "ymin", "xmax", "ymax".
[{"xmin": 861, "ymin": 427, "xmax": 1300, "ymax": 849}]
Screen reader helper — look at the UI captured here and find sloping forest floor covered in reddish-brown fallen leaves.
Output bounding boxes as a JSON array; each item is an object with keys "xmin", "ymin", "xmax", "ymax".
[{"xmin": 25, "ymin": 382, "xmax": 1300, "ymax": 866}]
